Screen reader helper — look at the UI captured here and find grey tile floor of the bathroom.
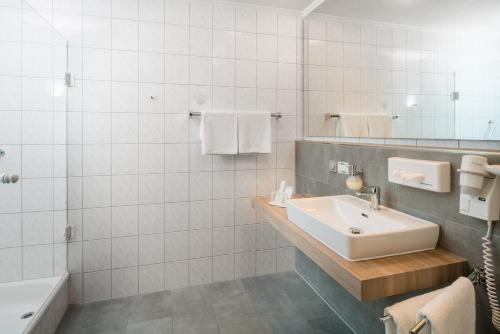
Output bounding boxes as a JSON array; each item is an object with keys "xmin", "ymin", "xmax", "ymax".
[{"xmin": 57, "ymin": 272, "xmax": 352, "ymax": 334}]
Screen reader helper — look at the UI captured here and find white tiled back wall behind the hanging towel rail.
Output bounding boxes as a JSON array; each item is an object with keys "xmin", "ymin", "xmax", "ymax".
[{"xmin": 28, "ymin": 0, "xmax": 302, "ymax": 302}]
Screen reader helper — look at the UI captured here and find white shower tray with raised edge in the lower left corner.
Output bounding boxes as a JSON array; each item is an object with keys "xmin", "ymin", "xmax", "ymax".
[{"xmin": 0, "ymin": 274, "xmax": 68, "ymax": 334}]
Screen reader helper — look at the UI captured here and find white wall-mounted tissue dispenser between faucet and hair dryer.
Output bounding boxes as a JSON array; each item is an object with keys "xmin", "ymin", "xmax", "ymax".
[{"xmin": 387, "ymin": 157, "xmax": 451, "ymax": 193}]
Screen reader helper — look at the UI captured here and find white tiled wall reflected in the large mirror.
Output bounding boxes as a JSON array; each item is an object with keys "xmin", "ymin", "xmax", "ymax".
[{"xmin": 305, "ymin": 15, "xmax": 500, "ymax": 139}]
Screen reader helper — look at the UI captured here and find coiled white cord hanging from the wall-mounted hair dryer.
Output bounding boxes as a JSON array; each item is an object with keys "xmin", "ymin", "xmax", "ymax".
[{"xmin": 482, "ymin": 221, "xmax": 500, "ymax": 331}]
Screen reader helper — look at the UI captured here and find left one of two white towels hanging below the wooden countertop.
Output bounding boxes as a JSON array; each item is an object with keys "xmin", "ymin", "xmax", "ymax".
[{"xmin": 384, "ymin": 290, "xmax": 441, "ymax": 334}]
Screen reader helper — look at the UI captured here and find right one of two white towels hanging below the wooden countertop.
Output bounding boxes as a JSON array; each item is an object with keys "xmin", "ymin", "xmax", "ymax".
[{"xmin": 417, "ymin": 277, "xmax": 476, "ymax": 334}]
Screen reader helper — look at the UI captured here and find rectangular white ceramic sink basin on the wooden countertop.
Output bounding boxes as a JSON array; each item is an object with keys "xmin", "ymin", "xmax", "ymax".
[{"xmin": 287, "ymin": 195, "xmax": 439, "ymax": 261}]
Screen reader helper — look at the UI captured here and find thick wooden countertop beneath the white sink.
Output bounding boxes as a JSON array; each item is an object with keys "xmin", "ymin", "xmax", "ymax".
[{"xmin": 253, "ymin": 196, "xmax": 467, "ymax": 301}]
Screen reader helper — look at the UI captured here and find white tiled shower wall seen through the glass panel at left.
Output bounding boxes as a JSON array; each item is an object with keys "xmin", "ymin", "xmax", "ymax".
[{"xmin": 0, "ymin": 0, "xmax": 66, "ymax": 283}]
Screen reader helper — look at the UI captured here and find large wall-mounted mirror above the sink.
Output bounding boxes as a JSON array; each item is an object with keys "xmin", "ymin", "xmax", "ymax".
[{"xmin": 304, "ymin": 0, "xmax": 500, "ymax": 140}]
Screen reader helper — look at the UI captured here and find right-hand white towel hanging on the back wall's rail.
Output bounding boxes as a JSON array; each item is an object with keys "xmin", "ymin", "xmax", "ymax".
[{"xmin": 238, "ymin": 111, "xmax": 272, "ymax": 153}]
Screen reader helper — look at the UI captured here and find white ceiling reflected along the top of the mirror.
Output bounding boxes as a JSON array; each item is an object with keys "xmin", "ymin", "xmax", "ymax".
[{"xmin": 315, "ymin": 0, "xmax": 500, "ymax": 34}]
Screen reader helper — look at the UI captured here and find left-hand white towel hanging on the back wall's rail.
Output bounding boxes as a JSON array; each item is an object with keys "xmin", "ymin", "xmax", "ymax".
[{"xmin": 200, "ymin": 110, "xmax": 238, "ymax": 154}]
